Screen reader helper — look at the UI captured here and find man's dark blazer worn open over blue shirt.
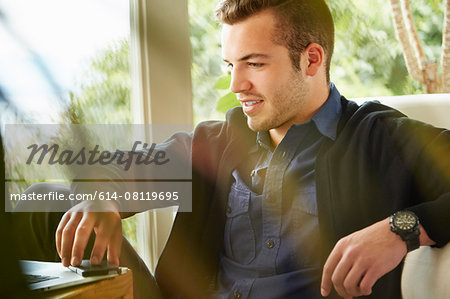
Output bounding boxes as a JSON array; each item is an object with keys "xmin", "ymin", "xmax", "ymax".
[{"xmin": 156, "ymin": 97, "xmax": 450, "ymax": 298}]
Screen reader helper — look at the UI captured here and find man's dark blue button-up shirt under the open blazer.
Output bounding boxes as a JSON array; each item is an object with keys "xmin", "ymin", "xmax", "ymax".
[{"xmin": 217, "ymin": 83, "xmax": 342, "ymax": 298}]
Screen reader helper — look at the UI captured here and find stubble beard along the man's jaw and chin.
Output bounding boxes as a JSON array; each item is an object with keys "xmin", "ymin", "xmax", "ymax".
[{"xmin": 247, "ymin": 71, "xmax": 308, "ymax": 132}]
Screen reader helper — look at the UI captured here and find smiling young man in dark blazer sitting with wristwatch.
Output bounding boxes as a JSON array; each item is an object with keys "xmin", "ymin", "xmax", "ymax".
[{"xmin": 43, "ymin": 0, "xmax": 450, "ymax": 298}]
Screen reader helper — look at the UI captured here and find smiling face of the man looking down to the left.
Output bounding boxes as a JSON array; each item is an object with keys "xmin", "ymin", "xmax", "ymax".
[{"xmin": 222, "ymin": 11, "xmax": 308, "ymax": 131}]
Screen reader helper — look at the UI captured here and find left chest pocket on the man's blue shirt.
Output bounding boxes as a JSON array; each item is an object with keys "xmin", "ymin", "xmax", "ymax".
[{"xmin": 224, "ymin": 184, "xmax": 256, "ymax": 265}]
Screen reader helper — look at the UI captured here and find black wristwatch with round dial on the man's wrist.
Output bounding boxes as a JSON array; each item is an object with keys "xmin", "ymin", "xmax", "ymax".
[{"xmin": 390, "ymin": 210, "xmax": 420, "ymax": 252}]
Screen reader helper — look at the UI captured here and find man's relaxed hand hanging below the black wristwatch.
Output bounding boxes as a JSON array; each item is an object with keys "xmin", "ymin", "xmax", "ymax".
[{"xmin": 321, "ymin": 218, "xmax": 407, "ymax": 299}]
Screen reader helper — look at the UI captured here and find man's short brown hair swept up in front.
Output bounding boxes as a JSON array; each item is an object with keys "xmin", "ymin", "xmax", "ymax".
[{"xmin": 216, "ymin": 0, "xmax": 334, "ymax": 82}]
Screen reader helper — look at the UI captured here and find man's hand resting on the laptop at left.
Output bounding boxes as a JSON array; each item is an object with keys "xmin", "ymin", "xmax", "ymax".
[{"xmin": 56, "ymin": 201, "xmax": 122, "ymax": 267}]
